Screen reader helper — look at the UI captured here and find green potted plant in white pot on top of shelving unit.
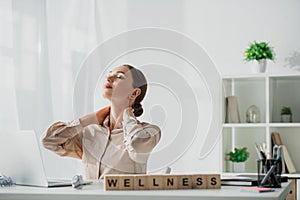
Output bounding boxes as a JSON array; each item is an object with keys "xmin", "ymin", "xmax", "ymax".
[{"xmin": 244, "ymin": 41, "xmax": 275, "ymax": 73}]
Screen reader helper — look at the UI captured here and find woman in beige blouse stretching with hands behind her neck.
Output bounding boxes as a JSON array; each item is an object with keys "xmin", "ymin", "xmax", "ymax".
[{"xmin": 42, "ymin": 65, "xmax": 161, "ymax": 179}]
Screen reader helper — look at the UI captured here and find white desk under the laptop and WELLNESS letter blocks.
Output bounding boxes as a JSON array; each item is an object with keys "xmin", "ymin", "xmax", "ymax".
[{"xmin": 0, "ymin": 182, "xmax": 291, "ymax": 200}]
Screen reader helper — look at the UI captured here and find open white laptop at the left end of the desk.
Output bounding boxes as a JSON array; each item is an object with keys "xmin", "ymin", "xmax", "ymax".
[{"xmin": 0, "ymin": 130, "xmax": 72, "ymax": 187}]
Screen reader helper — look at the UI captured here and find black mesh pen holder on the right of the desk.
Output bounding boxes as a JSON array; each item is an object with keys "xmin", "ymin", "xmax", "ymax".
[{"xmin": 257, "ymin": 159, "xmax": 282, "ymax": 188}]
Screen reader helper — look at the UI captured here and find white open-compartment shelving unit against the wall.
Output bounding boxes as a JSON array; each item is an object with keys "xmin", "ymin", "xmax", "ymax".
[{"xmin": 222, "ymin": 74, "xmax": 300, "ymax": 173}]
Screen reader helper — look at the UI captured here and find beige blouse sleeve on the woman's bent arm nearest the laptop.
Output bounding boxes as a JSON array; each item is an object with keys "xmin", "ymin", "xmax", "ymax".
[{"xmin": 42, "ymin": 113, "xmax": 98, "ymax": 159}]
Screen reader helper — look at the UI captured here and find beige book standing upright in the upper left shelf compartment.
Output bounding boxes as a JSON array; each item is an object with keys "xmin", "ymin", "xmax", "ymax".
[{"xmin": 225, "ymin": 96, "xmax": 241, "ymax": 123}]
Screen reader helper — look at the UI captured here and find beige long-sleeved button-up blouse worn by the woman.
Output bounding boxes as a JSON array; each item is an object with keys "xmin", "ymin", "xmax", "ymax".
[{"xmin": 42, "ymin": 112, "xmax": 161, "ymax": 179}]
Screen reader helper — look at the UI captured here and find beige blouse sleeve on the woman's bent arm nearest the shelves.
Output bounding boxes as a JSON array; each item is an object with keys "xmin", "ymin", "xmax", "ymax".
[{"xmin": 123, "ymin": 109, "xmax": 161, "ymax": 163}]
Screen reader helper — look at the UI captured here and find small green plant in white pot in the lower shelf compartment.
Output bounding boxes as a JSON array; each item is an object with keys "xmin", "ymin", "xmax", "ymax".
[{"xmin": 227, "ymin": 147, "xmax": 250, "ymax": 172}]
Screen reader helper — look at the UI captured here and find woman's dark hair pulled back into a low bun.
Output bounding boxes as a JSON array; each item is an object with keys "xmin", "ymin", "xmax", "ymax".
[{"xmin": 124, "ymin": 65, "xmax": 147, "ymax": 117}]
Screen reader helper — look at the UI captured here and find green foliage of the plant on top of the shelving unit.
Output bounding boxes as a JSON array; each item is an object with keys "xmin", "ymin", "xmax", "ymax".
[{"xmin": 245, "ymin": 41, "xmax": 275, "ymax": 61}]
